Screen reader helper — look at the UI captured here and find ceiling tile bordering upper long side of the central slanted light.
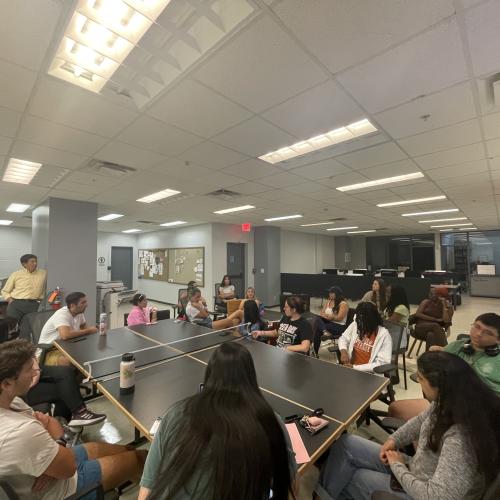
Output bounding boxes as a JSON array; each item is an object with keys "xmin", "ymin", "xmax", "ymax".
[{"xmin": 262, "ymin": 81, "xmax": 365, "ymax": 139}]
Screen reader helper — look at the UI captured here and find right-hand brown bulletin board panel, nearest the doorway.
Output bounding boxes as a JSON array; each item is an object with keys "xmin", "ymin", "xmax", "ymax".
[{"xmin": 168, "ymin": 247, "xmax": 205, "ymax": 286}]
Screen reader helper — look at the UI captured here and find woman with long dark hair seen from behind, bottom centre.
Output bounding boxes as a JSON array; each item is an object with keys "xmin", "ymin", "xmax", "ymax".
[{"xmin": 139, "ymin": 342, "xmax": 296, "ymax": 500}]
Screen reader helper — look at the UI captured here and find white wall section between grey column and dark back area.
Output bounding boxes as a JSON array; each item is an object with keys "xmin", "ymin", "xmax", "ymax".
[{"xmin": 281, "ymin": 230, "xmax": 335, "ymax": 274}]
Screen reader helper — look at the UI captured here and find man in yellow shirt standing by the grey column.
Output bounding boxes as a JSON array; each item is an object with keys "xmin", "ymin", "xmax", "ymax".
[{"xmin": 2, "ymin": 253, "xmax": 47, "ymax": 321}]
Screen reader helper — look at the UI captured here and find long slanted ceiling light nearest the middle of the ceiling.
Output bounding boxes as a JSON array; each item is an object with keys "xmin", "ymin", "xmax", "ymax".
[{"xmin": 259, "ymin": 118, "xmax": 377, "ymax": 164}]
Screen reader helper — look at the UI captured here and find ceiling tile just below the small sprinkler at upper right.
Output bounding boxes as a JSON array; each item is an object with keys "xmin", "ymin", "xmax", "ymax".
[{"xmin": 398, "ymin": 120, "xmax": 481, "ymax": 156}]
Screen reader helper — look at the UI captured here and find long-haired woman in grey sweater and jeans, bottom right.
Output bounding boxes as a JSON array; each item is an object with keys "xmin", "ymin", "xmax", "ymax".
[{"xmin": 316, "ymin": 352, "xmax": 500, "ymax": 500}]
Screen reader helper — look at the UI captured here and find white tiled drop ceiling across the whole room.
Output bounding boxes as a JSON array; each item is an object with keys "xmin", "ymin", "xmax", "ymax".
[{"xmin": 0, "ymin": 0, "xmax": 500, "ymax": 235}]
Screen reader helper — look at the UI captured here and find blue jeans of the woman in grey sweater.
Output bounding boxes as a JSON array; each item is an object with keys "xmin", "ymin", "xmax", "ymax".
[{"xmin": 315, "ymin": 434, "xmax": 411, "ymax": 500}]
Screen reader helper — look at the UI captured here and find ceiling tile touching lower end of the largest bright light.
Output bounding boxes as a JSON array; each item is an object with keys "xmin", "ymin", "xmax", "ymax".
[{"xmin": 29, "ymin": 77, "xmax": 138, "ymax": 137}]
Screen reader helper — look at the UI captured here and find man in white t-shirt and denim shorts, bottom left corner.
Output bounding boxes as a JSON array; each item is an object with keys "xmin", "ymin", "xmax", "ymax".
[{"xmin": 0, "ymin": 339, "xmax": 146, "ymax": 500}]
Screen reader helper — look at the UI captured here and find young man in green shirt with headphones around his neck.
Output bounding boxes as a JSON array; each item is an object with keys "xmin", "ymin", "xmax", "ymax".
[{"xmin": 389, "ymin": 313, "xmax": 500, "ymax": 420}]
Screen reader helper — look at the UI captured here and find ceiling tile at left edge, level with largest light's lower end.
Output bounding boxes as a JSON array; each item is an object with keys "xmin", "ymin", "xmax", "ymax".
[{"xmin": 0, "ymin": 60, "xmax": 36, "ymax": 111}]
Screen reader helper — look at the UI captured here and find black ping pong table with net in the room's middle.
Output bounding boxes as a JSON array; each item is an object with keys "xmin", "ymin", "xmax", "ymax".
[{"xmin": 55, "ymin": 320, "xmax": 388, "ymax": 472}]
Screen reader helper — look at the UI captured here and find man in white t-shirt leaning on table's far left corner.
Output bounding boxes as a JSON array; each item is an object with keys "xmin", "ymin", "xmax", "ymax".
[{"xmin": 38, "ymin": 292, "xmax": 97, "ymax": 365}]
